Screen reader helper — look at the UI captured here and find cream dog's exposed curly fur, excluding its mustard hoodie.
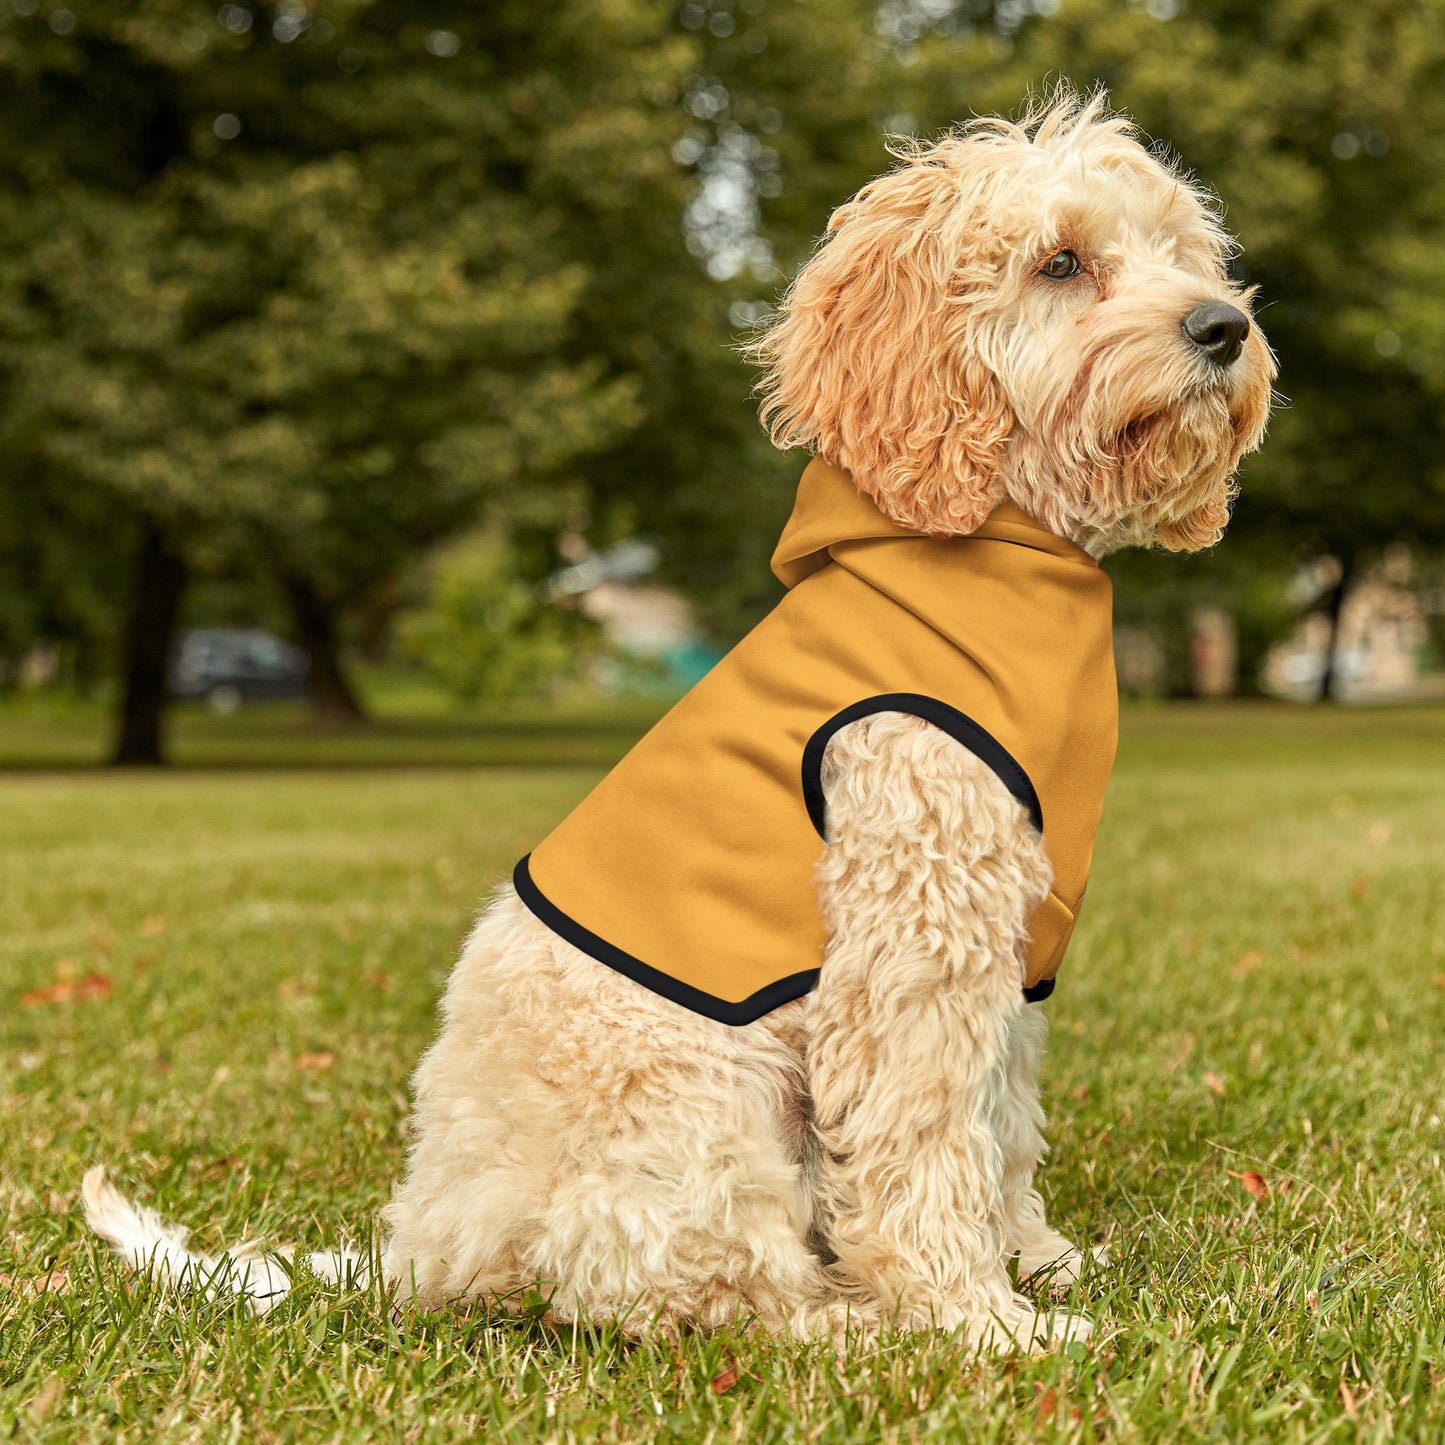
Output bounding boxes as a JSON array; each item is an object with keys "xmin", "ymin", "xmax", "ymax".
[{"xmin": 87, "ymin": 95, "xmax": 1273, "ymax": 1345}]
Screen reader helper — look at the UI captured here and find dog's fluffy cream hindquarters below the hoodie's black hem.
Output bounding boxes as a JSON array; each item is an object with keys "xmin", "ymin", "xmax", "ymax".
[{"xmin": 384, "ymin": 887, "xmax": 822, "ymax": 1334}]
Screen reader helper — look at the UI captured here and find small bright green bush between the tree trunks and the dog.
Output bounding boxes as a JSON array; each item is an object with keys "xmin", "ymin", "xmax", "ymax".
[{"xmin": 397, "ymin": 532, "xmax": 601, "ymax": 702}]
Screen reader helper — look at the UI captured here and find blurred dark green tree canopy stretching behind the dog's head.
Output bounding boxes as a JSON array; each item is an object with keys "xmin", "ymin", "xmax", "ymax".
[{"xmin": 0, "ymin": 0, "xmax": 1445, "ymax": 762}]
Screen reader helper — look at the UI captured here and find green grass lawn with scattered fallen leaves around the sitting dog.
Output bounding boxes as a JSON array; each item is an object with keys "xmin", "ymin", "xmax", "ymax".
[{"xmin": 0, "ymin": 707, "xmax": 1445, "ymax": 1442}]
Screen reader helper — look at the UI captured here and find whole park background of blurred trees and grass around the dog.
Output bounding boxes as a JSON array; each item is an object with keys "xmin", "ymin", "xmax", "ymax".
[{"xmin": 0, "ymin": 0, "xmax": 1445, "ymax": 1442}]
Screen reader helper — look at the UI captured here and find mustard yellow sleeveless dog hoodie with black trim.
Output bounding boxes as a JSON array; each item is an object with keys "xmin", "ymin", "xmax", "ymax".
[{"xmin": 516, "ymin": 461, "xmax": 1118, "ymax": 1023}]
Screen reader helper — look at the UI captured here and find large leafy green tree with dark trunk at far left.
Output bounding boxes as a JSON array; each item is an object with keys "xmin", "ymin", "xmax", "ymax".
[{"xmin": 0, "ymin": 0, "xmax": 688, "ymax": 763}]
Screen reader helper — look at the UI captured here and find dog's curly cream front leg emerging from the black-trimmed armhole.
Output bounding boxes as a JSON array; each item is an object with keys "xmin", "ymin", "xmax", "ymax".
[{"xmin": 808, "ymin": 714, "xmax": 1088, "ymax": 1347}]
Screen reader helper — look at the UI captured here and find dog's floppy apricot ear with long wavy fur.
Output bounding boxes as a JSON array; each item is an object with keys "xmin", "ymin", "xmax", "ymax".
[{"xmin": 747, "ymin": 139, "xmax": 1013, "ymax": 535}]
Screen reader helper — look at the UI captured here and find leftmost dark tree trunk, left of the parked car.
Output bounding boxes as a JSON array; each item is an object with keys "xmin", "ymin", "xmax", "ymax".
[{"xmin": 111, "ymin": 522, "xmax": 186, "ymax": 767}]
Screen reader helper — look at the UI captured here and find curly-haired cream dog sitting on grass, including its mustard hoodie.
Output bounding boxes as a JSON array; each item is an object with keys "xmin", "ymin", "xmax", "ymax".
[{"xmin": 87, "ymin": 95, "xmax": 1273, "ymax": 1345}]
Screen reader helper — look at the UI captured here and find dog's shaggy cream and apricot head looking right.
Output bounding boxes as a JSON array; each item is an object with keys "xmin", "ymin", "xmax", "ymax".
[{"xmin": 750, "ymin": 92, "xmax": 1274, "ymax": 555}]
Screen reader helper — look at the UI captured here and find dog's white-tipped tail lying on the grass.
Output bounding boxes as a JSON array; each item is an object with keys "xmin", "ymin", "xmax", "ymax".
[{"xmin": 81, "ymin": 1165, "xmax": 370, "ymax": 1315}]
